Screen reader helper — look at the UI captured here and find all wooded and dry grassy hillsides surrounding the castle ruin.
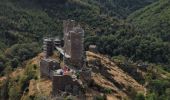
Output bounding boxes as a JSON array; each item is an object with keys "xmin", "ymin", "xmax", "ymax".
[{"xmin": 0, "ymin": 0, "xmax": 170, "ymax": 100}]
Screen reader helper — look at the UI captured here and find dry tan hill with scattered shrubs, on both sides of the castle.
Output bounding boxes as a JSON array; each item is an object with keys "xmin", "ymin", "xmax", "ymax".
[{"xmin": 0, "ymin": 52, "xmax": 170, "ymax": 100}]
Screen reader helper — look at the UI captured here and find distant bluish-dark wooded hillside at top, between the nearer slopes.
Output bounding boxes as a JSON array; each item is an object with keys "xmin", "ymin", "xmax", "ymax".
[{"xmin": 67, "ymin": 0, "xmax": 156, "ymax": 18}]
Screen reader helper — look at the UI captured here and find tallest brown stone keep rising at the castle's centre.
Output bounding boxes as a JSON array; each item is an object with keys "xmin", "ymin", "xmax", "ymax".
[{"xmin": 64, "ymin": 20, "xmax": 84, "ymax": 67}]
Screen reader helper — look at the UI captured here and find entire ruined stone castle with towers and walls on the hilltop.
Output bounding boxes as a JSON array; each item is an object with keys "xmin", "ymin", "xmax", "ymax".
[{"xmin": 40, "ymin": 20, "xmax": 91, "ymax": 95}]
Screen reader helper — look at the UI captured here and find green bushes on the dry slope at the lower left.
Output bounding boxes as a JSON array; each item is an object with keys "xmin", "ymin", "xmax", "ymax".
[{"xmin": 0, "ymin": 65, "xmax": 37, "ymax": 100}]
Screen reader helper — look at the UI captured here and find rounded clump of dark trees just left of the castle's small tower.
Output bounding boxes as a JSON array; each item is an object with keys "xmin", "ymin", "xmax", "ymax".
[{"xmin": 5, "ymin": 43, "xmax": 40, "ymax": 67}]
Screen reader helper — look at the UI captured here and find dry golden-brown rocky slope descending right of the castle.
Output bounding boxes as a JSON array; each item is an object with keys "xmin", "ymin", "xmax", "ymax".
[{"xmin": 86, "ymin": 52, "xmax": 146, "ymax": 99}]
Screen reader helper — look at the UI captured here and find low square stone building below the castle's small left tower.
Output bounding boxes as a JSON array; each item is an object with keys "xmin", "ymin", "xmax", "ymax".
[{"xmin": 40, "ymin": 58, "xmax": 60, "ymax": 78}]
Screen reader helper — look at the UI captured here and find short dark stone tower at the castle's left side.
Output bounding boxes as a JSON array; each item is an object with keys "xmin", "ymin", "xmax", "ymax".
[{"xmin": 43, "ymin": 38, "xmax": 54, "ymax": 58}]
